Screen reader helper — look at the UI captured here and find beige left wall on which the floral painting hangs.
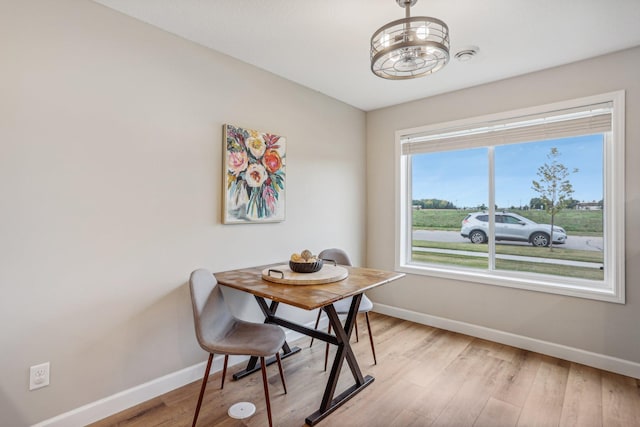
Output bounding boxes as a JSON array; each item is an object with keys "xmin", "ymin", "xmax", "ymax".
[{"xmin": 0, "ymin": 0, "xmax": 365, "ymax": 426}]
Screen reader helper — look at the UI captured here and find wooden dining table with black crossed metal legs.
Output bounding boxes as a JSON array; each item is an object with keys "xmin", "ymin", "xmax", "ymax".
[{"xmin": 214, "ymin": 263, "xmax": 404, "ymax": 426}]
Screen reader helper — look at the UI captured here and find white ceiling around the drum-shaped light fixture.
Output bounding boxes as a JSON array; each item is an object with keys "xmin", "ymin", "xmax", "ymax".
[{"xmin": 94, "ymin": 0, "xmax": 640, "ymax": 111}]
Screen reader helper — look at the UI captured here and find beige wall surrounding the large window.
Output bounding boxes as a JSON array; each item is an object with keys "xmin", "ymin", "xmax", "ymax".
[{"xmin": 367, "ymin": 48, "xmax": 640, "ymax": 363}]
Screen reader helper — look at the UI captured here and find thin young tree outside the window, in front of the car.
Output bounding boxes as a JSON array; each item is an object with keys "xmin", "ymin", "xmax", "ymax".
[{"xmin": 531, "ymin": 147, "xmax": 578, "ymax": 249}]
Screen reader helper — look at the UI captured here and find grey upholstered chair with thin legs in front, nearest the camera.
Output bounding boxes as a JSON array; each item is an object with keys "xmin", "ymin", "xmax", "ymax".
[{"xmin": 189, "ymin": 269, "xmax": 287, "ymax": 427}]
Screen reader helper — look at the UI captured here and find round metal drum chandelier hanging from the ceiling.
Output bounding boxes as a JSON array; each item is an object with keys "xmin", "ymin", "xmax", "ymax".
[{"xmin": 371, "ymin": 0, "xmax": 449, "ymax": 80}]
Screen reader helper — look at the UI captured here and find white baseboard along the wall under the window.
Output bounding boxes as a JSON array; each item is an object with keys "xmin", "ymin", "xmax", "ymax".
[{"xmin": 373, "ymin": 304, "xmax": 640, "ymax": 378}]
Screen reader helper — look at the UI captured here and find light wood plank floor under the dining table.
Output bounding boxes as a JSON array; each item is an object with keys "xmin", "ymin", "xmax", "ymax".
[{"xmin": 92, "ymin": 313, "xmax": 640, "ymax": 427}]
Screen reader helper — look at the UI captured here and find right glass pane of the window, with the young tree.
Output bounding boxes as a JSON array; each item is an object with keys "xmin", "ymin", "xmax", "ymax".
[{"xmin": 495, "ymin": 134, "xmax": 604, "ymax": 281}]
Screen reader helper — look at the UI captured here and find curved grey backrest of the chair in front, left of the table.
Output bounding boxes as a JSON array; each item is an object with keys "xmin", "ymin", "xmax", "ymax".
[{"xmin": 189, "ymin": 269, "xmax": 235, "ymax": 352}]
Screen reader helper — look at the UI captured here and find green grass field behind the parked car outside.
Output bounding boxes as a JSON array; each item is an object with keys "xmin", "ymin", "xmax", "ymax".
[{"xmin": 413, "ymin": 209, "xmax": 602, "ymax": 236}]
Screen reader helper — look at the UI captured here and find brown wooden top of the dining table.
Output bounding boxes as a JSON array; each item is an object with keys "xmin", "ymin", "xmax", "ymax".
[{"xmin": 214, "ymin": 263, "xmax": 404, "ymax": 310}]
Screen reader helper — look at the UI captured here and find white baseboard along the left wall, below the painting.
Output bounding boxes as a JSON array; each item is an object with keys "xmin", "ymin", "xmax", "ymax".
[{"xmin": 32, "ymin": 328, "xmax": 312, "ymax": 427}]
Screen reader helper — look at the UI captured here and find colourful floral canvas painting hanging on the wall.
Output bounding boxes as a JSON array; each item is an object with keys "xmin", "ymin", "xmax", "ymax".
[{"xmin": 223, "ymin": 124, "xmax": 286, "ymax": 224}]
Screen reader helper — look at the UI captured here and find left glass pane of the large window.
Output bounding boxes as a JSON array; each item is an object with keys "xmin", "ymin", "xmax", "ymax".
[{"xmin": 411, "ymin": 148, "xmax": 489, "ymax": 270}]
